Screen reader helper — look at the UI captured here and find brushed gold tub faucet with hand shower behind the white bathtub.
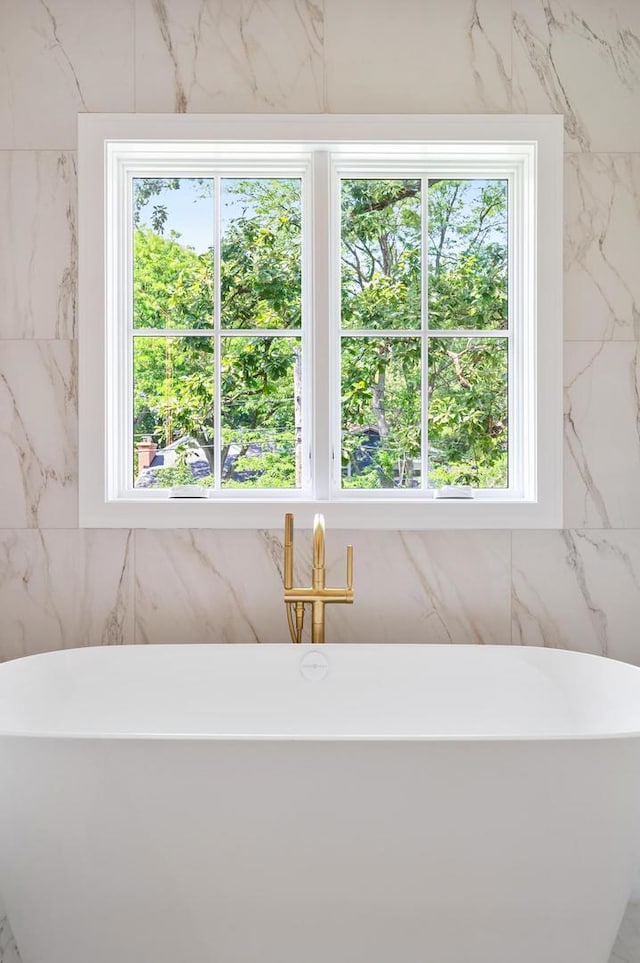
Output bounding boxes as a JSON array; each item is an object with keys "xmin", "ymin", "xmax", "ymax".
[{"xmin": 284, "ymin": 513, "xmax": 353, "ymax": 643}]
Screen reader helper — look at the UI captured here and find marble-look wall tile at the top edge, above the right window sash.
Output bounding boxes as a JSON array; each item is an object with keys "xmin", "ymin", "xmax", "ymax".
[{"xmin": 324, "ymin": 0, "xmax": 511, "ymax": 113}]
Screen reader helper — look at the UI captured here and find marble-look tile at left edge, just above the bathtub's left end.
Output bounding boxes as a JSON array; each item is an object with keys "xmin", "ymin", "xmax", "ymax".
[{"xmin": 0, "ymin": 529, "xmax": 134, "ymax": 660}]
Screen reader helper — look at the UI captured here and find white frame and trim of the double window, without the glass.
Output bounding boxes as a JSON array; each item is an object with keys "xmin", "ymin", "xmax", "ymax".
[{"xmin": 78, "ymin": 114, "xmax": 563, "ymax": 529}]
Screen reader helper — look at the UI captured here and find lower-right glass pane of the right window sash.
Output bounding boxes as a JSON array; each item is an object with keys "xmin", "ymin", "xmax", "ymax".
[{"xmin": 429, "ymin": 338, "xmax": 509, "ymax": 488}]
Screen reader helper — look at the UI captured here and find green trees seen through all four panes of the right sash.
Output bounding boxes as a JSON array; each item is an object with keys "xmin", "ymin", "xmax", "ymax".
[{"xmin": 342, "ymin": 180, "xmax": 508, "ymax": 487}]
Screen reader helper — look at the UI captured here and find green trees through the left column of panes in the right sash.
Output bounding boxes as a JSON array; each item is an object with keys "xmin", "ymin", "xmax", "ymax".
[{"xmin": 341, "ymin": 180, "xmax": 422, "ymax": 488}]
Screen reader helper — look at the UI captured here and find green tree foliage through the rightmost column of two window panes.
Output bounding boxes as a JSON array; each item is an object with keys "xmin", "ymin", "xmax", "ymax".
[{"xmin": 428, "ymin": 180, "xmax": 508, "ymax": 488}]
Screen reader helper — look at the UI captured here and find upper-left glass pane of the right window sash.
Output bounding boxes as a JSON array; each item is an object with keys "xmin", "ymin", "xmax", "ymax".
[{"xmin": 341, "ymin": 179, "xmax": 421, "ymax": 330}]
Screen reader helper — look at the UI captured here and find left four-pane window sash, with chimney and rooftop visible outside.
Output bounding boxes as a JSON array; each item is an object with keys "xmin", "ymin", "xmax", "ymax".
[{"xmin": 131, "ymin": 175, "xmax": 308, "ymax": 497}]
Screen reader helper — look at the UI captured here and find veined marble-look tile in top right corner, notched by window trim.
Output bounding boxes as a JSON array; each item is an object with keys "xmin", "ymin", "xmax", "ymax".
[{"xmin": 512, "ymin": 0, "xmax": 640, "ymax": 151}]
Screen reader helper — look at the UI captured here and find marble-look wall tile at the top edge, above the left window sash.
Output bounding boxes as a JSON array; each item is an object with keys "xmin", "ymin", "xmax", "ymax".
[{"xmin": 136, "ymin": 0, "xmax": 325, "ymax": 113}]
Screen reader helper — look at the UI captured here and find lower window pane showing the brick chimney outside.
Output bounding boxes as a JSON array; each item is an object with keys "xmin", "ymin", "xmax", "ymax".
[{"xmin": 133, "ymin": 337, "xmax": 214, "ymax": 488}]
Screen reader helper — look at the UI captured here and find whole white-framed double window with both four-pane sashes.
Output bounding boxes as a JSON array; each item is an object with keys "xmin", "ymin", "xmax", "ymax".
[{"xmin": 79, "ymin": 115, "xmax": 562, "ymax": 528}]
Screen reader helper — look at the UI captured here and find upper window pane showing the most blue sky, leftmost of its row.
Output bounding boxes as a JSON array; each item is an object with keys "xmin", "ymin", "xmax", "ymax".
[{"xmin": 133, "ymin": 177, "xmax": 214, "ymax": 328}]
